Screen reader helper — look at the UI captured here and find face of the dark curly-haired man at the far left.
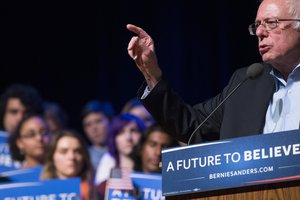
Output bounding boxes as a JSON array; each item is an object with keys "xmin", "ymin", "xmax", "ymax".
[{"xmin": 3, "ymin": 98, "xmax": 26, "ymax": 133}]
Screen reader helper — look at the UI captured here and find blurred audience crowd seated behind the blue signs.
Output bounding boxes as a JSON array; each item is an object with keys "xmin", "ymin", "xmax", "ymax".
[{"xmin": 0, "ymin": 84, "xmax": 179, "ymax": 200}]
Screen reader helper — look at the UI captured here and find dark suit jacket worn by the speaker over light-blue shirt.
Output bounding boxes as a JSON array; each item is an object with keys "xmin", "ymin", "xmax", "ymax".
[{"xmin": 138, "ymin": 63, "xmax": 275, "ymax": 143}]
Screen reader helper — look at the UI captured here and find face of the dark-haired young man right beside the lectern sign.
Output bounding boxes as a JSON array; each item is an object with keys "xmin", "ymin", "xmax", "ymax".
[{"xmin": 141, "ymin": 131, "xmax": 171, "ymax": 173}]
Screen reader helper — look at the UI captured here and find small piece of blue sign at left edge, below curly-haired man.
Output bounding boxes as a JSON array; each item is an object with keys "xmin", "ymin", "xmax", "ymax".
[{"xmin": 0, "ymin": 131, "xmax": 21, "ymax": 172}]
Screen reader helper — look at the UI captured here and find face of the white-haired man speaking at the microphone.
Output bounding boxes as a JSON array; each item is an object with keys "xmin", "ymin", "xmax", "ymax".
[{"xmin": 256, "ymin": 0, "xmax": 300, "ymax": 69}]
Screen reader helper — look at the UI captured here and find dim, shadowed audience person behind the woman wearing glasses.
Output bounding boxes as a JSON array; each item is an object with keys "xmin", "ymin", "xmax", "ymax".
[{"xmin": 43, "ymin": 101, "xmax": 68, "ymax": 133}]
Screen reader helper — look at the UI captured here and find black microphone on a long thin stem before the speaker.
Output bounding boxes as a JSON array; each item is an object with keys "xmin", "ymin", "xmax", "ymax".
[{"xmin": 187, "ymin": 63, "xmax": 263, "ymax": 145}]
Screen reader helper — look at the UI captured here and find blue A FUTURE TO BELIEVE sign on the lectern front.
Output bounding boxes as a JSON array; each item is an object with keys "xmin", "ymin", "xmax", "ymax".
[{"xmin": 162, "ymin": 130, "xmax": 300, "ymax": 196}]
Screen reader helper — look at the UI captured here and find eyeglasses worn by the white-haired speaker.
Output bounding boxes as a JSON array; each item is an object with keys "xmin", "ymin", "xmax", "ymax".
[{"xmin": 248, "ymin": 18, "xmax": 300, "ymax": 35}]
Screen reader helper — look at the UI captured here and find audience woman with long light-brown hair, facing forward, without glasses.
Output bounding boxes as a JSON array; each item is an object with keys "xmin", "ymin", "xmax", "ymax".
[{"xmin": 41, "ymin": 130, "xmax": 96, "ymax": 200}]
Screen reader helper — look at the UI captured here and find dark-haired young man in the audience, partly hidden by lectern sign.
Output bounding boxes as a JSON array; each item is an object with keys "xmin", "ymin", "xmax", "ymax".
[{"xmin": 132, "ymin": 124, "xmax": 179, "ymax": 173}]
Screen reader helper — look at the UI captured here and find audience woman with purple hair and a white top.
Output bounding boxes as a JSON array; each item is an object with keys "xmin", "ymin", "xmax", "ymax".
[{"xmin": 95, "ymin": 114, "xmax": 145, "ymax": 194}]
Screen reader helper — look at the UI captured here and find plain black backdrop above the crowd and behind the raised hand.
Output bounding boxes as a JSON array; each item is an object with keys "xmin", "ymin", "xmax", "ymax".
[{"xmin": 0, "ymin": 0, "xmax": 261, "ymax": 130}]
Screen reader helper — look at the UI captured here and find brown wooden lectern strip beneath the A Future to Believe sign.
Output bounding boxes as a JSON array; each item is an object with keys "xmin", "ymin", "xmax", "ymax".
[{"xmin": 166, "ymin": 181, "xmax": 300, "ymax": 200}]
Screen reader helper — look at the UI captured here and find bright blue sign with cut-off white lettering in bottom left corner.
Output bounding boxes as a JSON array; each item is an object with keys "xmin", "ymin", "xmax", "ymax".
[{"xmin": 0, "ymin": 178, "xmax": 81, "ymax": 200}]
